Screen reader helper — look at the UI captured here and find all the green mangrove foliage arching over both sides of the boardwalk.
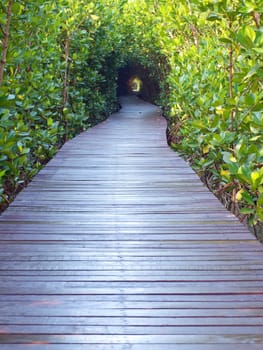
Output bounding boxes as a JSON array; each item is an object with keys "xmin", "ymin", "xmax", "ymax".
[{"xmin": 0, "ymin": 0, "xmax": 263, "ymax": 237}]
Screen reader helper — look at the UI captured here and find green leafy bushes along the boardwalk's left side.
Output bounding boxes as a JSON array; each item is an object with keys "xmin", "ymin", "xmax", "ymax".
[{"xmin": 0, "ymin": 0, "xmax": 125, "ymax": 205}]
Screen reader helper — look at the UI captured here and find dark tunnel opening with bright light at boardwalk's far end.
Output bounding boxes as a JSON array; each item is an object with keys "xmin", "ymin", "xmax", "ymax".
[{"xmin": 117, "ymin": 62, "xmax": 160, "ymax": 102}]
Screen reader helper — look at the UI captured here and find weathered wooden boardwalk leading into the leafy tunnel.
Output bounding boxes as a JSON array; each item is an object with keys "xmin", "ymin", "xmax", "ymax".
[{"xmin": 0, "ymin": 97, "xmax": 263, "ymax": 350}]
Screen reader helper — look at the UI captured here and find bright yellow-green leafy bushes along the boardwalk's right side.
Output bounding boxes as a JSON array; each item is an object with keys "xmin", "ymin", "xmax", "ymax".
[{"xmin": 115, "ymin": 0, "xmax": 263, "ymax": 225}]
